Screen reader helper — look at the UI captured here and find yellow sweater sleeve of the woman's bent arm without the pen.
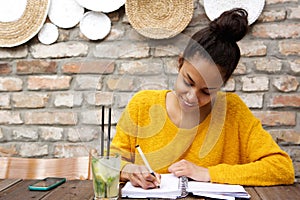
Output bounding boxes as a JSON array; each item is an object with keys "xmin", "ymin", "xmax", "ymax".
[{"xmin": 208, "ymin": 95, "xmax": 294, "ymax": 186}]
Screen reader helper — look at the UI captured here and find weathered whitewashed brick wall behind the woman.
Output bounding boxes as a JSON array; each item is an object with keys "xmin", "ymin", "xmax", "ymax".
[{"xmin": 0, "ymin": 0, "xmax": 300, "ymax": 181}]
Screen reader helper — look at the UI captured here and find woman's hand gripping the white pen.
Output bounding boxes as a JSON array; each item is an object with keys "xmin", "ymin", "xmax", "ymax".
[{"xmin": 120, "ymin": 164, "xmax": 160, "ymax": 189}]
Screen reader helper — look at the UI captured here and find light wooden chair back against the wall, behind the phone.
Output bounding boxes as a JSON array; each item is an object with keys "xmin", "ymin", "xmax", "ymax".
[{"xmin": 0, "ymin": 156, "xmax": 91, "ymax": 180}]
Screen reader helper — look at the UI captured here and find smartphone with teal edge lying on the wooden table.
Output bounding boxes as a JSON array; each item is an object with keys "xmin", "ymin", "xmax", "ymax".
[{"xmin": 28, "ymin": 177, "xmax": 66, "ymax": 191}]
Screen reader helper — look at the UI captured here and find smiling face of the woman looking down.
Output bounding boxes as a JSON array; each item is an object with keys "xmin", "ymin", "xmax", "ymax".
[{"xmin": 175, "ymin": 56, "xmax": 223, "ymax": 112}]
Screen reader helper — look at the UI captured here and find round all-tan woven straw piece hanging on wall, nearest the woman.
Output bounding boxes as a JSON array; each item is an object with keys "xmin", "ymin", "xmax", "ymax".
[{"xmin": 125, "ymin": 0, "xmax": 194, "ymax": 39}]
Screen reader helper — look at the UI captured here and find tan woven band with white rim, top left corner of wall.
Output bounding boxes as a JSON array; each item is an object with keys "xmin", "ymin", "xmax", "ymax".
[{"xmin": 0, "ymin": 0, "xmax": 50, "ymax": 47}]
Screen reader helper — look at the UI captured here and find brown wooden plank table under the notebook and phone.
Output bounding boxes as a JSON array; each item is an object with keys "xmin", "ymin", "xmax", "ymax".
[{"xmin": 0, "ymin": 179, "xmax": 300, "ymax": 200}]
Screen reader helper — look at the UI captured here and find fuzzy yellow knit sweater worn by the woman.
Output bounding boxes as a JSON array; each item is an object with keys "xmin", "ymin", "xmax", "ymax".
[{"xmin": 111, "ymin": 90, "xmax": 294, "ymax": 186}]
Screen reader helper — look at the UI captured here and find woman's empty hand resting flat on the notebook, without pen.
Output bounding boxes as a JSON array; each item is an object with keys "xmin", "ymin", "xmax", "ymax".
[{"xmin": 168, "ymin": 160, "xmax": 210, "ymax": 182}]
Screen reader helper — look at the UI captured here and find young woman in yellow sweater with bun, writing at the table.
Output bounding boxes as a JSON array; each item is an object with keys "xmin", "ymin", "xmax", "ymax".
[{"xmin": 111, "ymin": 9, "xmax": 294, "ymax": 188}]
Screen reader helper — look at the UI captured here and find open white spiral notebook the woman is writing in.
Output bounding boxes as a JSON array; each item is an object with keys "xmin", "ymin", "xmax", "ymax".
[{"xmin": 121, "ymin": 174, "xmax": 250, "ymax": 199}]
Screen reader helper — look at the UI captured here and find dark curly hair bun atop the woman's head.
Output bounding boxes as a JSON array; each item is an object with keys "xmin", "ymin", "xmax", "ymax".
[{"xmin": 209, "ymin": 8, "xmax": 248, "ymax": 42}]
